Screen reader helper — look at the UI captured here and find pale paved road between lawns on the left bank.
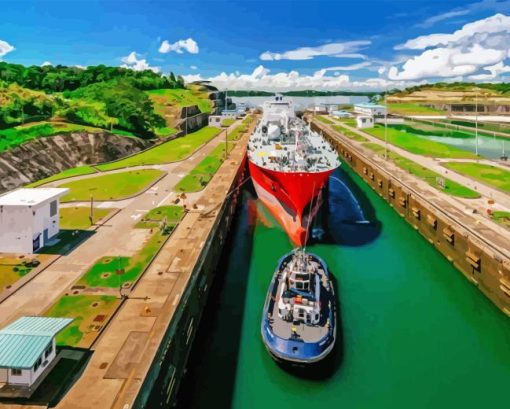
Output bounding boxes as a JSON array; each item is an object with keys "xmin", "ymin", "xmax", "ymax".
[{"xmin": 0, "ymin": 123, "xmax": 243, "ymax": 327}]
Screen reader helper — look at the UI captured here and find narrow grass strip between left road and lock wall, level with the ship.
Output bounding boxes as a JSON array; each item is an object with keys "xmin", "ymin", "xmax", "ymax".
[{"xmin": 175, "ymin": 117, "xmax": 252, "ymax": 192}]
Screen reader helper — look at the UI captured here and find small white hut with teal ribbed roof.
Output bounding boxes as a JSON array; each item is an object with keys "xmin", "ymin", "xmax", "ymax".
[{"xmin": 0, "ymin": 317, "xmax": 73, "ymax": 397}]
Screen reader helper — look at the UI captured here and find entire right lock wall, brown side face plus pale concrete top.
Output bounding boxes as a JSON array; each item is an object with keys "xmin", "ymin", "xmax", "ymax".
[{"xmin": 312, "ymin": 116, "xmax": 510, "ymax": 316}]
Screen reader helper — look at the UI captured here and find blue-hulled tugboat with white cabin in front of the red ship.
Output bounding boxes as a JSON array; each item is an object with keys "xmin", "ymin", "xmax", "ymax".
[{"xmin": 261, "ymin": 248, "xmax": 336, "ymax": 366}]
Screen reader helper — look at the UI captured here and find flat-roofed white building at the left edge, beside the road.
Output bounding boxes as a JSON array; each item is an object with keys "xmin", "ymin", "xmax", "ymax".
[{"xmin": 0, "ymin": 188, "xmax": 69, "ymax": 253}]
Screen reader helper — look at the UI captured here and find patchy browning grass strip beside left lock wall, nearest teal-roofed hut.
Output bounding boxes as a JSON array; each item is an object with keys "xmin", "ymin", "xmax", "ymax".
[{"xmin": 45, "ymin": 206, "xmax": 184, "ymax": 348}]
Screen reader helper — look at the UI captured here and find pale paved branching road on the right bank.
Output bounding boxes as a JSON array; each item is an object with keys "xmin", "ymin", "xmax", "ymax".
[{"xmin": 328, "ymin": 115, "xmax": 510, "ymax": 210}]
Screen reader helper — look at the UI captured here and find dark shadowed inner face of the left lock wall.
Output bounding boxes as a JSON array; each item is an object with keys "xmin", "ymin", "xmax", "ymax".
[{"xmin": 133, "ymin": 157, "xmax": 246, "ymax": 408}]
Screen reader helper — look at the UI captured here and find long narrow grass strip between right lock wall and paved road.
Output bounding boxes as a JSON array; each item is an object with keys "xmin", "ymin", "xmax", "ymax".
[{"xmin": 363, "ymin": 143, "xmax": 480, "ymax": 199}]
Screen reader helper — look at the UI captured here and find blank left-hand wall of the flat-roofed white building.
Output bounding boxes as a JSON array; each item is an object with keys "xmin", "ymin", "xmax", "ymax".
[{"xmin": 0, "ymin": 206, "xmax": 33, "ymax": 253}]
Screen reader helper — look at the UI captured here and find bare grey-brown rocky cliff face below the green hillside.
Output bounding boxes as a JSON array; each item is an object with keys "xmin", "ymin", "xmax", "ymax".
[{"xmin": 0, "ymin": 132, "xmax": 150, "ymax": 193}]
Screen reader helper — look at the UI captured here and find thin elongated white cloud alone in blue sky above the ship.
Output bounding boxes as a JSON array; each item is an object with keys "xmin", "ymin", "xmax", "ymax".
[{"xmin": 259, "ymin": 40, "xmax": 371, "ymax": 61}]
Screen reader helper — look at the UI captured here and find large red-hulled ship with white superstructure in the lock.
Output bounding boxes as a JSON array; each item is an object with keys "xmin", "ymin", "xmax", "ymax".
[{"xmin": 248, "ymin": 95, "xmax": 340, "ymax": 246}]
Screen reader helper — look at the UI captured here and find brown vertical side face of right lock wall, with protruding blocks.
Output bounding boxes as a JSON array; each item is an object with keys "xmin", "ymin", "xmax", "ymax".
[{"xmin": 312, "ymin": 119, "xmax": 510, "ymax": 316}]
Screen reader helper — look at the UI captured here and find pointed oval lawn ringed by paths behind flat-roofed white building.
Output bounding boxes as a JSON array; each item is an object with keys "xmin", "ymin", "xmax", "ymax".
[{"xmin": 59, "ymin": 169, "xmax": 165, "ymax": 202}]
